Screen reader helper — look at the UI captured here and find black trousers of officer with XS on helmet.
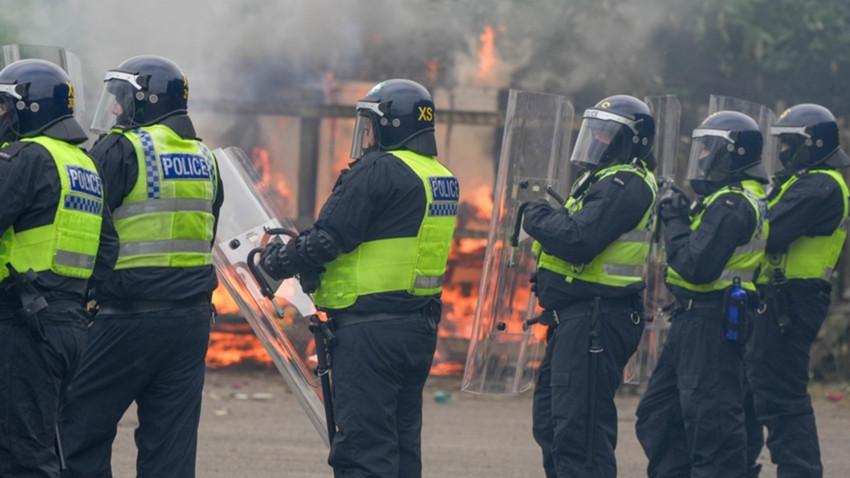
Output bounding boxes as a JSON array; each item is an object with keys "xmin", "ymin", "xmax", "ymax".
[{"xmin": 328, "ymin": 314, "xmax": 439, "ymax": 478}]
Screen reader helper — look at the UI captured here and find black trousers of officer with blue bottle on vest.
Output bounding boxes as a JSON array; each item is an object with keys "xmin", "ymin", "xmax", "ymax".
[{"xmin": 635, "ymin": 306, "xmax": 747, "ymax": 478}]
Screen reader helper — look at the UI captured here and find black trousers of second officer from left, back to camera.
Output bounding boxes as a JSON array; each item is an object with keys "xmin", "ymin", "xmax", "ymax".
[{"xmin": 61, "ymin": 304, "xmax": 213, "ymax": 478}]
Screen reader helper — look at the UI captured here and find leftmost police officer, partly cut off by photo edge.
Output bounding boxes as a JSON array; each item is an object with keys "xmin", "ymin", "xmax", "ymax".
[{"xmin": 0, "ymin": 59, "xmax": 117, "ymax": 477}]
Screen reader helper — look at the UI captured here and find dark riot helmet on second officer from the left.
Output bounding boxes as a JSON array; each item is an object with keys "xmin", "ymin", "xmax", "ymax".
[{"xmin": 91, "ymin": 55, "xmax": 189, "ymax": 134}]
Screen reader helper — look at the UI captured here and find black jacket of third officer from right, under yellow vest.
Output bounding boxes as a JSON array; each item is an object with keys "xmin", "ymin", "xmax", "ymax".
[{"xmin": 523, "ymin": 167, "xmax": 653, "ymax": 309}]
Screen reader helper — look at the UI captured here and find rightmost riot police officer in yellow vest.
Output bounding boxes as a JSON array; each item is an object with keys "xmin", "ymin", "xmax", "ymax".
[{"xmin": 747, "ymin": 104, "xmax": 850, "ymax": 477}]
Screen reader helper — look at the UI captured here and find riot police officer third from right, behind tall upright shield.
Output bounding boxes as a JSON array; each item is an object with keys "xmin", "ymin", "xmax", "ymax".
[{"xmin": 523, "ymin": 95, "xmax": 657, "ymax": 478}]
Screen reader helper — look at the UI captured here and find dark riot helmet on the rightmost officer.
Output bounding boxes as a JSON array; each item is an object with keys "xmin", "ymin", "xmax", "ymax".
[{"xmin": 770, "ymin": 103, "xmax": 850, "ymax": 171}]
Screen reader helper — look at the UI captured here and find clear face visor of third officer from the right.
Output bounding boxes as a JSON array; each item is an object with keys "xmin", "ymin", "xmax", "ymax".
[{"xmin": 570, "ymin": 110, "xmax": 629, "ymax": 169}]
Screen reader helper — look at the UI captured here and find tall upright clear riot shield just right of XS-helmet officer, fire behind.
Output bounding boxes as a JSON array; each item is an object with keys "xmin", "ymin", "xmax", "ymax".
[{"xmin": 461, "ymin": 90, "xmax": 574, "ymax": 394}]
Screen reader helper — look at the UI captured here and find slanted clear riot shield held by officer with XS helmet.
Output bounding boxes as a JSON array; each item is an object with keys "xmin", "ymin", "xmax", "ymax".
[{"xmin": 213, "ymin": 148, "xmax": 328, "ymax": 444}]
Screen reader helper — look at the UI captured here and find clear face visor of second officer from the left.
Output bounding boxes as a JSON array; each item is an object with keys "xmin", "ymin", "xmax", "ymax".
[{"xmin": 90, "ymin": 71, "xmax": 142, "ymax": 134}]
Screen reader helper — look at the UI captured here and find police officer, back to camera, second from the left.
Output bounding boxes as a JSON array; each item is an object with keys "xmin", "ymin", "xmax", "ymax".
[{"xmin": 63, "ymin": 55, "xmax": 223, "ymax": 477}]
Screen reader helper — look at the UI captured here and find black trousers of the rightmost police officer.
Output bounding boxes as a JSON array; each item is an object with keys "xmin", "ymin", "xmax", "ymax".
[{"xmin": 746, "ymin": 290, "xmax": 829, "ymax": 478}]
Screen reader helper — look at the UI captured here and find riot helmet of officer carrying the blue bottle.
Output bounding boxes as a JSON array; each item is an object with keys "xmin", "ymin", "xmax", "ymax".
[{"xmin": 688, "ymin": 111, "xmax": 767, "ymax": 196}]
